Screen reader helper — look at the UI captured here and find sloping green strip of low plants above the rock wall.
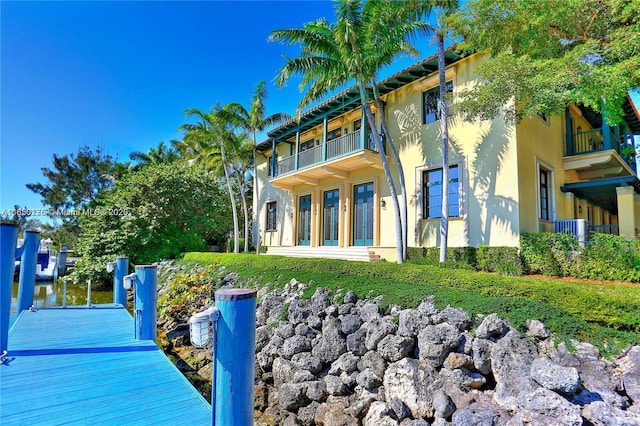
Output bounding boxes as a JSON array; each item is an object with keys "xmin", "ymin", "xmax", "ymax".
[{"xmin": 180, "ymin": 253, "xmax": 640, "ymax": 356}]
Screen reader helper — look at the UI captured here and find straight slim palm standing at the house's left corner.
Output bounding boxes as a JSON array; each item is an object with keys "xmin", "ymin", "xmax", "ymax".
[{"xmin": 234, "ymin": 80, "xmax": 291, "ymax": 254}]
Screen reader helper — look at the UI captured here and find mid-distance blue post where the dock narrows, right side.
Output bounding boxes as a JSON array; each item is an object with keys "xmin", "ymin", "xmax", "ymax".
[{"xmin": 133, "ymin": 265, "xmax": 158, "ymax": 342}]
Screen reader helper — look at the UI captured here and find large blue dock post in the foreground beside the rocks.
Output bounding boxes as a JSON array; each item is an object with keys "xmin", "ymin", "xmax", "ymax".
[{"xmin": 212, "ymin": 288, "xmax": 257, "ymax": 426}]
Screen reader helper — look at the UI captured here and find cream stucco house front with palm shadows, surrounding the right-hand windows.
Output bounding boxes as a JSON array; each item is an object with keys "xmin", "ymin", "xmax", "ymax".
[{"xmin": 382, "ymin": 55, "xmax": 519, "ymax": 247}]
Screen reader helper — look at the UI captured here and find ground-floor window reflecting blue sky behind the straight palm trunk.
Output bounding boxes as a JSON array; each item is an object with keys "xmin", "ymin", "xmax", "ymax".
[{"xmin": 422, "ymin": 165, "xmax": 461, "ymax": 219}]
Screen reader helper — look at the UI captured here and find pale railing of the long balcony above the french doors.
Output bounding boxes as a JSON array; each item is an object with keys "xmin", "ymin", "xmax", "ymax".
[{"xmin": 275, "ymin": 130, "xmax": 384, "ymax": 176}]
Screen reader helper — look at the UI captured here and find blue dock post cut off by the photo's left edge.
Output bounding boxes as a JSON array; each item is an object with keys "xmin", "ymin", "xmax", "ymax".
[{"xmin": 0, "ymin": 223, "xmax": 18, "ymax": 356}]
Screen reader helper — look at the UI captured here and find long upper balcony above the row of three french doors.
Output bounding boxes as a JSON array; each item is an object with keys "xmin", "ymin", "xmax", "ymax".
[{"xmin": 271, "ymin": 130, "xmax": 384, "ymax": 189}]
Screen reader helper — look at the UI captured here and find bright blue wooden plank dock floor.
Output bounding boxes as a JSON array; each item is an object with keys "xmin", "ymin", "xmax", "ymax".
[{"xmin": 0, "ymin": 305, "xmax": 211, "ymax": 425}]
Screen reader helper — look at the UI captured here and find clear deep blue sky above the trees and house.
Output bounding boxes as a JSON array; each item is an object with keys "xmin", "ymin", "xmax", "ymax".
[{"xmin": 0, "ymin": 1, "xmax": 432, "ymax": 216}]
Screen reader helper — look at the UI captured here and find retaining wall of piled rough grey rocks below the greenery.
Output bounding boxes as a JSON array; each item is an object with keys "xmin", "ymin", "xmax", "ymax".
[{"xmin": 160, "ymin": 274, "xmax": 640, "ymax": 426}]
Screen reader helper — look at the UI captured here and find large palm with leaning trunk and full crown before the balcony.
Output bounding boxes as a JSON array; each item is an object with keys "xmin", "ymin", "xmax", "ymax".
[{"xmin": 269, "ymin": 0, "xmax": 427, "ymax": 263}]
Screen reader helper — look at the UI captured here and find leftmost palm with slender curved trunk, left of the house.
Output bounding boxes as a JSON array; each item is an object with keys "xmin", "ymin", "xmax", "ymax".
[{"xmin": 179, "ymin": 104, "xmax": 240, "ymax": 253}]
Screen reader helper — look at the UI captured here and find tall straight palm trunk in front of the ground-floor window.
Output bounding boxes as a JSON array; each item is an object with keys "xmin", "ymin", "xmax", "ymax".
[{"xmin": 437, "ymin": 32, "xmax": 449, "ymax": 263}]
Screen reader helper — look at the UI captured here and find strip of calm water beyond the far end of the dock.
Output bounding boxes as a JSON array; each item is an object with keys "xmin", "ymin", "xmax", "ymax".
[{"xmin": 9, "ymin": 281, "xmax": 113, "ymax": 324}]
